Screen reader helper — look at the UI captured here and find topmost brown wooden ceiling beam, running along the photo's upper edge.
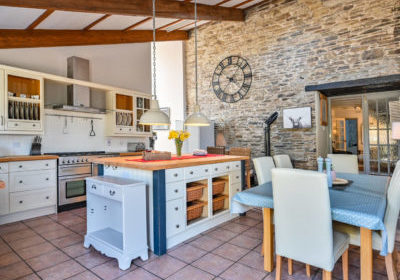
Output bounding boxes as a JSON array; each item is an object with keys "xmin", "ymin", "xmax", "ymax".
[{"xmin": 0, "ymin": 0, "xmax": 245, "ymax": 21}]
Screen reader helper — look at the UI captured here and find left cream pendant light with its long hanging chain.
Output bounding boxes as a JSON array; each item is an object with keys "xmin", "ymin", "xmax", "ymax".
[{"xmin": 139, "ymin": 0, "xmax": 171, "ymax": 125}]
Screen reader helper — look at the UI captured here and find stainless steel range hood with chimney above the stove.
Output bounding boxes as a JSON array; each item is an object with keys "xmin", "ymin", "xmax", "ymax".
[{"xmin": 53, "ymin": 56, "xmax": 106, "ymax": 114}]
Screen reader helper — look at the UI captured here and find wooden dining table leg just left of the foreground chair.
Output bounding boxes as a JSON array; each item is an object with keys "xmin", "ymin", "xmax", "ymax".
[{"xmin": 263, "ymin": 208, "xmax": 274, "ymax": 272}]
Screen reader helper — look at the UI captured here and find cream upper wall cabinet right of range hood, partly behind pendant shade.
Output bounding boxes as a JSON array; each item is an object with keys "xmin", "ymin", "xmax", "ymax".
[{"xmin": 106, "ymin": 91, "xmax": 151, "ymax": 137}]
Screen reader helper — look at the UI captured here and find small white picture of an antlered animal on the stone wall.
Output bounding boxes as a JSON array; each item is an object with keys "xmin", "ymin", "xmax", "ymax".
[{"xmin": 283, "ymin": 107, "xmax": 311, "ymax": 129}]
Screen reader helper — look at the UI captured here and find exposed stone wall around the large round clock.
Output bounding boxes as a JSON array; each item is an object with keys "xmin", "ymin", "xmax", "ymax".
[{"xmin": 186, "ymin": 0, "xmax": 400, "ymax": 168}]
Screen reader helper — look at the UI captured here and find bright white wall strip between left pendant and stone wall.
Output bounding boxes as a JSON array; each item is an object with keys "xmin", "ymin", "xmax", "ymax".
[{"xmin": 155, "ymin": 41, "xmax": 187, "ymax": 153}]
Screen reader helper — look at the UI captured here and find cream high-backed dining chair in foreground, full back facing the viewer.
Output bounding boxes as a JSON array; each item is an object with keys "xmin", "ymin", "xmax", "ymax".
[{"xmin": 271, "ymin": 168, "xmax": 349, "ymax": 280}]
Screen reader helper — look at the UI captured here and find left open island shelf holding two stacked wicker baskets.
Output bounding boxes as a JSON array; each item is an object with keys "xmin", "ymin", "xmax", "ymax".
[{"xmin": 186, "ymin": 179, "xmax": 208, "ymax": 225}]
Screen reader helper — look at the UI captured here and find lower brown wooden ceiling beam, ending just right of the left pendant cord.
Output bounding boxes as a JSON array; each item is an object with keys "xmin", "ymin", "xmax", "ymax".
[{"xmin": 0, "ymin": 29, "xmax": 189, "ymax": 49}]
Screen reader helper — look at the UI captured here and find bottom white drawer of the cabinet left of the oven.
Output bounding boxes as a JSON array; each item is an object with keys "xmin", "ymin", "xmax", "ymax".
[{"xmin": 10, "ymin": 189, "xmax": 56, "ymax": 212}]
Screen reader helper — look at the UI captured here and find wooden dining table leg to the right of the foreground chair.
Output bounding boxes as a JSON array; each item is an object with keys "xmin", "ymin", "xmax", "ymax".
[{"xmin": 360, "ymin": 228, "xmax": 373, "ymax": 280}]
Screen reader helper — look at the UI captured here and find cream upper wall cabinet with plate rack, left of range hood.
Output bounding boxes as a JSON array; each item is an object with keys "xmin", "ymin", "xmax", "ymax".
[{"xmin": 0, "ymin": 70, "xmax": 44, "ymax": 134}]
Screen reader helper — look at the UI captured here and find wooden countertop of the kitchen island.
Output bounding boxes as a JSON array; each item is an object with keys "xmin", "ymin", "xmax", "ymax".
[{"xmin": 92, "ymin": 155, "xmax": 248, "ymax": 171}]
